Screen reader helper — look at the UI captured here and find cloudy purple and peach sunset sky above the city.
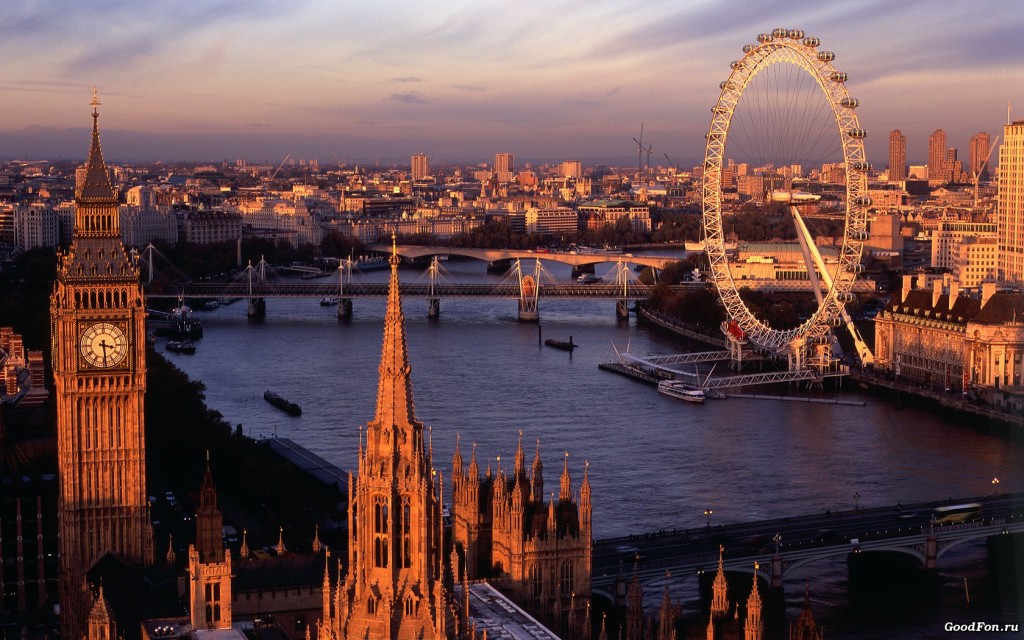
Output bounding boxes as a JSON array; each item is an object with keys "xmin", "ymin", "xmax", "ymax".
[{"xmin": 0, "ymin": 0, "xmax": 1024, "ymax": 166}]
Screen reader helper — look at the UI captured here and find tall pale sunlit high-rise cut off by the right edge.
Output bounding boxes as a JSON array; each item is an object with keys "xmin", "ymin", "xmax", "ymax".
[{"xmin": 996, "ymin": 120, "xmax": 1024, "ymax": 285}]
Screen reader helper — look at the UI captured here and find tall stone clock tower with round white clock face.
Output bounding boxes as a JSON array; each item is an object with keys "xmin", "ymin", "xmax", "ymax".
[{"xmin": 50, "ymin": 91, "xmax": 153, "ymax": 638}]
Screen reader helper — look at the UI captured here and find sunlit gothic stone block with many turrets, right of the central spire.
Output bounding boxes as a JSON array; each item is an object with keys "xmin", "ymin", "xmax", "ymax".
[{"xmin": 452, "ymin": 434, "xmax": 593, "ymax": 638}]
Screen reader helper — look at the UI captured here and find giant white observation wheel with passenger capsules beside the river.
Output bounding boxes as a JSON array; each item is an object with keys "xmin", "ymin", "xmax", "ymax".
[{"xmin": 702, "ymin": 29, "xmax": 871, "ymax": 360}]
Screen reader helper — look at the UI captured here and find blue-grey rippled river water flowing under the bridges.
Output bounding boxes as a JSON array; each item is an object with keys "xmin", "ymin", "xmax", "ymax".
[{"xmin": 158, "ymin": 261, "xmax": 1024, "ymax": 638}]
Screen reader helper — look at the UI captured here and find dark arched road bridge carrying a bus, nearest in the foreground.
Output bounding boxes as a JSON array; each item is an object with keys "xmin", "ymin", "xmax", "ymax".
[{"xmin": 591, "ymin": 494, "xmax": 1024, "ymax": 602}]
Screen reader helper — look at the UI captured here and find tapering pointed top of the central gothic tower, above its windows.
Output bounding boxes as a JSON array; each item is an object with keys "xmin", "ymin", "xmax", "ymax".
[{"xmin": 374, "ymin": 237, "xmax": 416, "ymax": 429}]
